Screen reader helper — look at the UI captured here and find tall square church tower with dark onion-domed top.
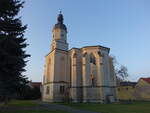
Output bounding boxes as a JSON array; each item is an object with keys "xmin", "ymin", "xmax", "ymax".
[{"xmin": 42, "ymin": 12, "xmax": 69, "ymax": 102}]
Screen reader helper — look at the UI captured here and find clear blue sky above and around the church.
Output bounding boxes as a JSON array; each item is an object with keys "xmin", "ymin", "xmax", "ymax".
[{"xmin": 20, "ymin": 0, "xmax": 150, "ymax": 81}]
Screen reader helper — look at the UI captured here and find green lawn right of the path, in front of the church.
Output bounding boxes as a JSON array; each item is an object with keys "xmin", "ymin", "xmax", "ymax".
[{"xmin": 64, "ymin": 102, "xmax": 150, "ymax": 113}]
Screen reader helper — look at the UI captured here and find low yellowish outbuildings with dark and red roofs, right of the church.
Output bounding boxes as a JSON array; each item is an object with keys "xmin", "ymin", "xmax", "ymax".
[{"xmin": 117, "ymin": 78, "xmax": 150, "ymax": 101}]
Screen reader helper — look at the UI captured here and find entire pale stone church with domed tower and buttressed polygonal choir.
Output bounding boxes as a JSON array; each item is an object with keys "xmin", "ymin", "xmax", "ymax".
[{"xmin": 42, "ymin": 13, "xmax": 116, "ymax": 103}]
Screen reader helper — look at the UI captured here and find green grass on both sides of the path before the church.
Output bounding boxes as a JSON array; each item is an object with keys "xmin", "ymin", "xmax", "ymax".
[{"xmin": 0, "ymin": 100, "xmax": 150, "ymax": 113}]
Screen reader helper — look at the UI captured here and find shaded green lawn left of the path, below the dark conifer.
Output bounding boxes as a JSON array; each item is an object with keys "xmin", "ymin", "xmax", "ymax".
[{"xmin": 0, "ymin": 100, "xmax": 66, "ymax": 113}]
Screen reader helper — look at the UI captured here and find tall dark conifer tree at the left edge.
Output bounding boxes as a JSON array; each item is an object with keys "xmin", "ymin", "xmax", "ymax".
[{"xmin": 0, "ymin": 0, "xmax": 30, "ymax": 103}]
